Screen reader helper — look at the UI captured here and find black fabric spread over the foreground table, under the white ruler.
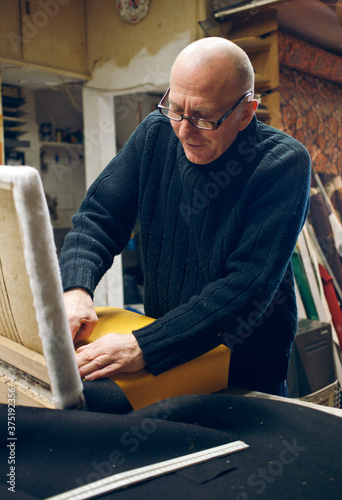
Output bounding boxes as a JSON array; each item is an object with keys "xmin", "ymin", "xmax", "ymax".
[{"xmin": 0, "ymin": 395, "xmax": 342, "ymax": 500}]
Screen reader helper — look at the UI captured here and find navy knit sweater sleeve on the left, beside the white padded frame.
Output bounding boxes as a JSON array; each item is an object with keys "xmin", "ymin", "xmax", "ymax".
[{"xmin": 59, "ymin": 119, "xmax": 146, "ymax": 296}]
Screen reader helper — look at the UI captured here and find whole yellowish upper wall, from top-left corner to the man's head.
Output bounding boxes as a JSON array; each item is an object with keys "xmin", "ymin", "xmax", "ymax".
[{"xmin": 0, "ymin": 0, "xmax": 206, "ymax": 89}]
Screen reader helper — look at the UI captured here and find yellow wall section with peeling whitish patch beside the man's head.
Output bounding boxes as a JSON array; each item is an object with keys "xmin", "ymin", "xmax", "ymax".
[{"xmin": 86, "ymin": 0, "xmax": 205, "ymax": 94}]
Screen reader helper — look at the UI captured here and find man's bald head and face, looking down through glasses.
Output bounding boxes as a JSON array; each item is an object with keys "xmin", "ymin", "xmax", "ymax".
[{"xmin": 167, "ymin": 37, "xmax": 258, "ymax": 165}]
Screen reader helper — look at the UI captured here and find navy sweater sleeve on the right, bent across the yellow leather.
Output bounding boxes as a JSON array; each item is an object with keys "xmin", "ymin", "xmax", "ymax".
[{"xmin": 133, "ymin": 141, "xmax": 311, "ymax": 375}]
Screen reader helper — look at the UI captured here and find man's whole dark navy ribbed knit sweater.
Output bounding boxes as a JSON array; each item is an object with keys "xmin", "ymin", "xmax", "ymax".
[{"xmin": 60, "ymin": 112, "xmax": 310, "ymax": 390}]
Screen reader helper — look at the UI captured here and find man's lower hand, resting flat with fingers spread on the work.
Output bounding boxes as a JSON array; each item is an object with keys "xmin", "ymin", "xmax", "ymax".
[{"xmin": 76, "ymin": 333, "xmax": 146, "ymax": 380}]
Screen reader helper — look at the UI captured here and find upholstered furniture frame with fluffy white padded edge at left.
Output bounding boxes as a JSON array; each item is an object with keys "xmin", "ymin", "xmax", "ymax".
[{"xmin": 0, "ymin": 166, "xmax": 84, "ymax": 408}]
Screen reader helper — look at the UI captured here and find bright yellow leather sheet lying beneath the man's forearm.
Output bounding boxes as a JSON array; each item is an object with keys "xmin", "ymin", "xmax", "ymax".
[{"xmin": 81, "ymin": 307, "xmax": 230, "ymax": 410}]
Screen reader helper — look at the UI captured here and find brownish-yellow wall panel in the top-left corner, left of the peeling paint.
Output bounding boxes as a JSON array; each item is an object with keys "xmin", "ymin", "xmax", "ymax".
[{"xmin": 0, "ymin": 0, "xmax": 88, "ymax": 77}]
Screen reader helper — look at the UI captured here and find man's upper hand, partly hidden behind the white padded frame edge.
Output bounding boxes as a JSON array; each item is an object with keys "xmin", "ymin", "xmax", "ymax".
[{"xmin": 64, "ymin": 288, "xmax": 98, "ymax": 344}]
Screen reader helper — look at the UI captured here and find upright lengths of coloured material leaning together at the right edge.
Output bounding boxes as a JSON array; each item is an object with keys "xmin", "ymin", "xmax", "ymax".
[{"xmin": 292, "ymin": 173, "xmax": 342, "ymax": 398}]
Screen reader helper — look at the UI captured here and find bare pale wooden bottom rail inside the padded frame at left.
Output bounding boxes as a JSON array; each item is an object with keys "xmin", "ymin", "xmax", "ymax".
[{"xmin": 0, "ymin": 336, "xmax": 50, "ymax": 384}]
